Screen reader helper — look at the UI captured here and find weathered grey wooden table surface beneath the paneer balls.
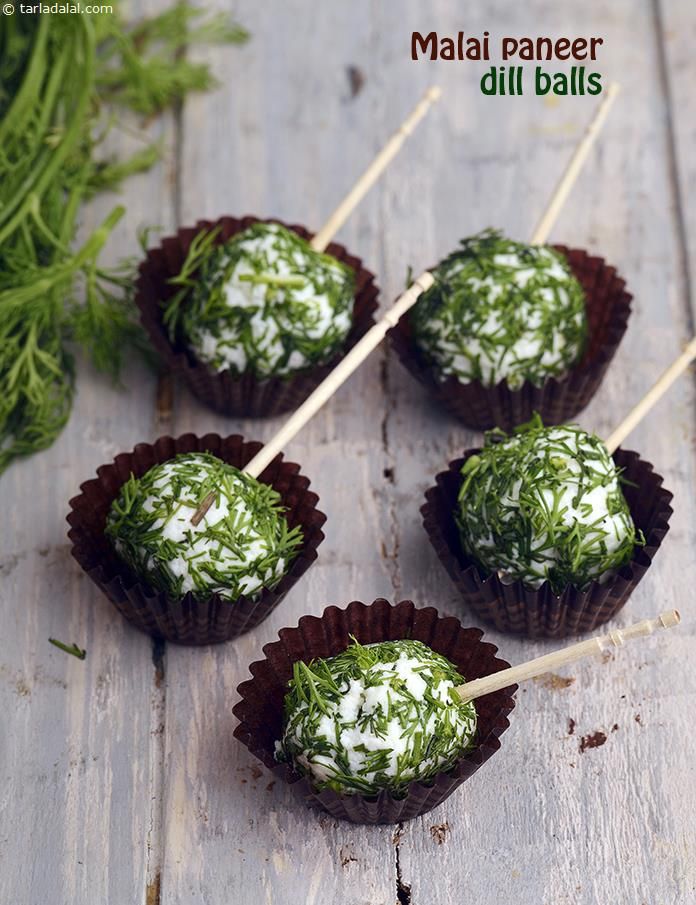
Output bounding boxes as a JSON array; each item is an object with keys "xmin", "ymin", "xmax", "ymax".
[{"xmin": 0, "ymin": 0, "xmax": 696, "ymax": 905}]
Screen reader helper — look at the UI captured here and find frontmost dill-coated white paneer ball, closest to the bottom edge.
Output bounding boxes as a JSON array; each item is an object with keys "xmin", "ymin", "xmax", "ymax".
[{"xmin": 276, "ymin": 640, "xmax": 476, "ymax": 797}]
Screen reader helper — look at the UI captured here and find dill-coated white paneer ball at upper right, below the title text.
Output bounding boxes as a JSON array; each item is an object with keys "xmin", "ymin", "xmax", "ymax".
[{"xmin": 411, "ymin": 230, "xmax": 588, "ymax": 389}]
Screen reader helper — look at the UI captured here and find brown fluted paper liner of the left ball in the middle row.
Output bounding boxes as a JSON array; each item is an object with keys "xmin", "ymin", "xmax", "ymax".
[{"xmin": 67, "ymin": 434, "xmax": 326, "ymax": 645}]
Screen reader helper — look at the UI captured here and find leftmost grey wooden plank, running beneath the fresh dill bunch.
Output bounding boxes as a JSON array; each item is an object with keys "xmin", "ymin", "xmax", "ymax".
[{"xmin": 0, "ymin": 24, "xmax": 171, "ymax": 905}]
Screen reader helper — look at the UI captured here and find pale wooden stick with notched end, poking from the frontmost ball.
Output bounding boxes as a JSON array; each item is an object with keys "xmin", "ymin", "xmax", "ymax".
[{"xmin": 457, "ymin": 610, "xmax": 681, "ymax": 703}]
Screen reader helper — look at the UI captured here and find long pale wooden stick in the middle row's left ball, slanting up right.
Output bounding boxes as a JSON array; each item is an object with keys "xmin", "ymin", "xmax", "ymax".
[{"xmin": 244, "ymin": 270, "xmax": 434, "ymax": 478}]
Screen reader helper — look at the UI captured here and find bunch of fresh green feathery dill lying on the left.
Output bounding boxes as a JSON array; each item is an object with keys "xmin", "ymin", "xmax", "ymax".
[{"xmin": 0, "ymin": 7, "xmax": 246, "ymax": 472}]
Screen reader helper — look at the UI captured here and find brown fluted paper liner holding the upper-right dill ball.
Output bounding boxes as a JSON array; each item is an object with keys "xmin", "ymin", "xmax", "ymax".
[{"xmin": 389, "ymin": 245, "xmax": 632, "ymax": 431}]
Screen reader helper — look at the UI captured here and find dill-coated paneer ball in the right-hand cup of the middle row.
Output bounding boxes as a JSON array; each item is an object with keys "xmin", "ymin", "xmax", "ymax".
[{"xmin": 456, "ymin": 416, "xmax": 643, "ymax": 594}]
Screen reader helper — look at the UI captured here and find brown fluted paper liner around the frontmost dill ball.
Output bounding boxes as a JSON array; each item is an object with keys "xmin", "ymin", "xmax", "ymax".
[{"xmin": 233, "ymin": 598, "xmax": 517, "ymax": 824}]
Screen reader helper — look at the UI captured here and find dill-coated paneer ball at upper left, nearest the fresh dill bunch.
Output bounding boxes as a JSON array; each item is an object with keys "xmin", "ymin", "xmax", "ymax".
[{"xmin": 171, "ymin": 223, "xmax": 355, "ymax": 379}]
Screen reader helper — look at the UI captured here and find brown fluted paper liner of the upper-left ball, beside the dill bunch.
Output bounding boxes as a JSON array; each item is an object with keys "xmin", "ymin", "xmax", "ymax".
[{"xmin": 135, "ymin": 216, "xmax": 379, "ymax": 418}]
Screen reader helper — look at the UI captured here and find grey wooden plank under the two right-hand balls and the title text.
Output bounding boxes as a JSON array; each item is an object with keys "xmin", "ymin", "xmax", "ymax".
[{"xmin": 381, "ymin": 3, "xmax": 694, "ymax": 903}]
